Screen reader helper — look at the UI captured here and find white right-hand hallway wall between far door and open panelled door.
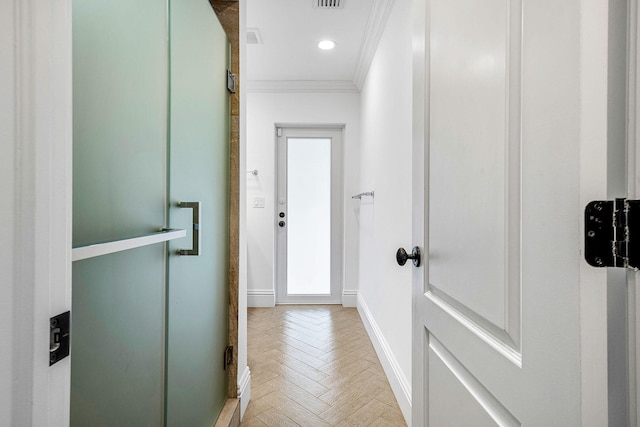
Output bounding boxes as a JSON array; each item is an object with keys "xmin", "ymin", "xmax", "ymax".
[{"xmin": 358, "ymin": 0, "xmax": 413, "ymax": 420}]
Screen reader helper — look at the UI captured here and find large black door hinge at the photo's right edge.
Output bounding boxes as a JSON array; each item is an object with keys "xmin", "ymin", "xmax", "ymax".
[{"xmin": 584, "ymin": 199, "xmax": 640, "ymax": 269}]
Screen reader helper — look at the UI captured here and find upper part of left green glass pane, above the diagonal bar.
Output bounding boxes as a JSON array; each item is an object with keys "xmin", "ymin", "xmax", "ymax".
[{"xmin": 73, "ymin": 0, "xmax": 168, "ymax": 246}]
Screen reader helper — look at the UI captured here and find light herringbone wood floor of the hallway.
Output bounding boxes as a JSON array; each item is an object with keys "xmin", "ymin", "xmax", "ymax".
[{"xmin": 240, "ymin": 305, "xmax": 406, "ymax": 427}]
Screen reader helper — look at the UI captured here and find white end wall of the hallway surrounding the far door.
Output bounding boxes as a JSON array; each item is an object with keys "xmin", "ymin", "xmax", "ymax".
[{"xmin": 246, "ymin": 92, "xmax": 360, "ymax": 307}]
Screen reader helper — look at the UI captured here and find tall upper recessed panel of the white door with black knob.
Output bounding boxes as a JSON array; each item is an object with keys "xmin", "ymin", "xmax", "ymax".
[{"xmin": 429, "ymin": 0, "xmax": 521, "ymax": 330}]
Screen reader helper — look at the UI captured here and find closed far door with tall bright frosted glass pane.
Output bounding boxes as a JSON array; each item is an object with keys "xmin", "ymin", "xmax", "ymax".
[{"xmin": 275, "ymin": 127, "xmax": 342, "ymax": 304}]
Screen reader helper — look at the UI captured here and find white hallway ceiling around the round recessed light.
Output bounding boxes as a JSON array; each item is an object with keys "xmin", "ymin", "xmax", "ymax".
[{"xmin": 245, "ymin": 0, "xmax": 392, "ymax": 90}]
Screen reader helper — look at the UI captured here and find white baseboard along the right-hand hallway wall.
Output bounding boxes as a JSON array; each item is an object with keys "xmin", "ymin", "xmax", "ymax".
[{"xmin": 357, "ymin": 294, "xmax": 411, "ymax": 425}]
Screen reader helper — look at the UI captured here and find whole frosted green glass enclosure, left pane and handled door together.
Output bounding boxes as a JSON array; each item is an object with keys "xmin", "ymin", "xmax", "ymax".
[{"xmin": 71, "ymin": 0, "xmax": 229, "ymax": 427}]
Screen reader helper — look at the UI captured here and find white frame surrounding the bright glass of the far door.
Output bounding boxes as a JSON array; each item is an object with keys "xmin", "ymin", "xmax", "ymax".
[{"xmin": 274, "ymin": 124, "xmax": 344, "ymax": 304}]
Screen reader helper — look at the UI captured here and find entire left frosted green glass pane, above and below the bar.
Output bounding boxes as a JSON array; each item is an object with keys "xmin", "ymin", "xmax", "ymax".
[{"xmin": 71, "ymin": 0, "xmax": 168, "ymax": 426}]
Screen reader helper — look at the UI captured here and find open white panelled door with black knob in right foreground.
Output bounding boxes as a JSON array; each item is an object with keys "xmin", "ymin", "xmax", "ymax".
[{"xmin": 407, "ymin": 0, "xmax": 608, "ymax": 427}]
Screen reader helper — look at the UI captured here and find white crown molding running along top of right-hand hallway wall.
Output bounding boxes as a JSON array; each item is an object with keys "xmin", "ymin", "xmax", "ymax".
[{"xmin": 353, "ymin": 0, "xmax": 394, "ymax": 90}]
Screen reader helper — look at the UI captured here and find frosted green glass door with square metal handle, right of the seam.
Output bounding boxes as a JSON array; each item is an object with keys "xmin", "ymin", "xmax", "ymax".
[{"xmin": 167, "ymin": 0, "xmax": 229, "ymax": 426}]
